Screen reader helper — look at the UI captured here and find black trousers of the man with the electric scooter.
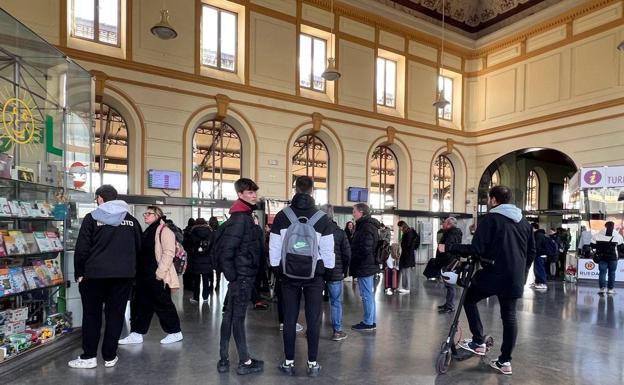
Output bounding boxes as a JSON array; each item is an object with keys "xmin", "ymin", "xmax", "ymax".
[{"xmin": 464, "ymin": 286, "xmax": 518, "ymax": 362}]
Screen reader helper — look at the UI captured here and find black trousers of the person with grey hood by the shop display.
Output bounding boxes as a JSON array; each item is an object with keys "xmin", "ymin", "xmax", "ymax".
[{"xmin": 78, "ymin": 278, "xmax": 132, "ymax": 361}]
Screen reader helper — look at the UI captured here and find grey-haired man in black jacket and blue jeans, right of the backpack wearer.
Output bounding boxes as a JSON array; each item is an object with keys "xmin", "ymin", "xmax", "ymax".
[{"xmin": 349, "ymin": 203, "xmax": 381, "ymax": 331}]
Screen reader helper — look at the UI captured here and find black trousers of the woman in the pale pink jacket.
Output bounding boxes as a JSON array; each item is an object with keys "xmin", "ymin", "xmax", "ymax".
[{"xmin": 130, "ymin": 278, "xmax": 181, "ymax": 334}]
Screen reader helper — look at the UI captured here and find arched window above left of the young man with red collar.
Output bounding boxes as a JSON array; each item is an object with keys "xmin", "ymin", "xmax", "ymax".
[{"xmin": 193, "ymin": 120, "xmax": 242, "ymax": 200}]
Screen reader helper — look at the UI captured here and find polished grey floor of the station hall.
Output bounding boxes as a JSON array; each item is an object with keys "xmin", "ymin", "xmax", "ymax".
[{"xmin": 2, "ymin": 268, "xmax": 624, "ymax": 385}]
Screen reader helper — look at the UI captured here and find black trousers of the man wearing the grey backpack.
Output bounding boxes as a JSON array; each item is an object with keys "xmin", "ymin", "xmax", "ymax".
[{"xmin": 281, "ymin": 277, "xmax": 325, "ymax": 361}]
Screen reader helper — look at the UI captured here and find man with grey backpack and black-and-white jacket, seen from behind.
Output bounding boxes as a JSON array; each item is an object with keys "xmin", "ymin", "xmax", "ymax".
[{"xmin": 269, "ymin": 176, "xmax": 335, "ymax": 377}]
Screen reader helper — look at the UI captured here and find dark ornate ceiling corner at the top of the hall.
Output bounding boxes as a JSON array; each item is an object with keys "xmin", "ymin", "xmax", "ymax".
[{"xmin": 375, "ymin": 0, "xmax": 560, "ymax": 39}]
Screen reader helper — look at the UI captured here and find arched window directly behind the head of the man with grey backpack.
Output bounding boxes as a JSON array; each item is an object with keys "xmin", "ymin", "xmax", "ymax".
[{"xmin": 290, "ymin": 134, "xmax": 329, "ymax": 204}]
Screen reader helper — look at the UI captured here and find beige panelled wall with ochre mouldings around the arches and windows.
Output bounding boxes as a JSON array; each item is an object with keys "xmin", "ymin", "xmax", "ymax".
[{"xmin": 0, "ymin": 0, "xmax": 624, "ymax": 216}]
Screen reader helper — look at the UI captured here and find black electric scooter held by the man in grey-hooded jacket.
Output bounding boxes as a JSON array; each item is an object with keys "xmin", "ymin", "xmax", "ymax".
[{"xmin": 436, "ymin": 255, "xmax": 494, "ymax": 374}]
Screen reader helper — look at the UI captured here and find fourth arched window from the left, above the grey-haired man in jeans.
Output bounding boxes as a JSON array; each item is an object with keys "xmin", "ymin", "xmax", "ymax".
[{"xmin": 369, "ymin": 146, "xmax": 399, "ymax": 209}]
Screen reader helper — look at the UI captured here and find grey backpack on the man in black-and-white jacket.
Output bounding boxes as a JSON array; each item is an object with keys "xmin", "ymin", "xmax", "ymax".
[{"xmin": 282, "ymin": 207, "xmax": 325, "ymax": 279}]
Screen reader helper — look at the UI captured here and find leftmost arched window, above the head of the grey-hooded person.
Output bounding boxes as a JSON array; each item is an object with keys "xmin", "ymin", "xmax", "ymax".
[{"xmin": 93, "ymin": 103, "xmax": 128, "ymax": 194}]
